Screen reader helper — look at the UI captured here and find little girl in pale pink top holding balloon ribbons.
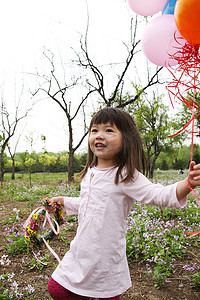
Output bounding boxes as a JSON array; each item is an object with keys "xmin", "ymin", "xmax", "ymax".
[{"xmin": 48, "ymin": 107, "xmax": 200, "ymax": 300}]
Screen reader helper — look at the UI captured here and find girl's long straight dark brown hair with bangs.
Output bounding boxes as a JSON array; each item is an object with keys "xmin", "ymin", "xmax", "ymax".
[{"xmin": 80, "ymin": 107, "xmax": 146, "ymax": 184}]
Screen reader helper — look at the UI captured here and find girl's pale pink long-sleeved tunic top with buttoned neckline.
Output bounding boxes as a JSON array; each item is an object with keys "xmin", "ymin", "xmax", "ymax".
[{"xmin": 52, "ymin": 168, "xmax": 186, "ymax": 298}]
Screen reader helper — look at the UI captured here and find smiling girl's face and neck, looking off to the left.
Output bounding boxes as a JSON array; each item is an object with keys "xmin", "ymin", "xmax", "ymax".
[{"xmin": 89, "ymin": 123, "xmax": 122, "ymax": 168}]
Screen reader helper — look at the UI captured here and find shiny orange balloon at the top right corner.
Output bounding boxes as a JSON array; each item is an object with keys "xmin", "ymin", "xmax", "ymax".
[{"xmin": 174, "ymin": 0, "xmax": 200, "ymax": 44}]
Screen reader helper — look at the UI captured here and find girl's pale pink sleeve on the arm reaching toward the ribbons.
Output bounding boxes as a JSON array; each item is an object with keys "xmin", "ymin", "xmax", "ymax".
[{"xmin": 124, "ymin": 171, "xmax": 187, "ymax": 208}]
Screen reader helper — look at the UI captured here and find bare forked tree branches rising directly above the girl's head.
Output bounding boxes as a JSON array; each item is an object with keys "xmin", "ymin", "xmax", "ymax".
[{"xmin": 76, "ymin": 16, "xmax": 162, "ymax": 108}]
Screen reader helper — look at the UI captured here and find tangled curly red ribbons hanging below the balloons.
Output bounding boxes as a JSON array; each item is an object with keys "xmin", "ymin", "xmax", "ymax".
[{"xmin": 166, "ymin": 42, "xmax": 200, "ymax": 237}]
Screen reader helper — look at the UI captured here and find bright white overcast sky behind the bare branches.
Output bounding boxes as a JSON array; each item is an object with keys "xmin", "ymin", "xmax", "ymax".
[{"xmin": 0, "ymin": 0, "xmax": 166, "ymax": 152}]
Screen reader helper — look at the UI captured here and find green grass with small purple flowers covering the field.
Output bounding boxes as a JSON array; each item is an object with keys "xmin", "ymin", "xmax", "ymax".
[{"xmin": 0, "ymin": 171, "xmax": 200, "ymax": 299}]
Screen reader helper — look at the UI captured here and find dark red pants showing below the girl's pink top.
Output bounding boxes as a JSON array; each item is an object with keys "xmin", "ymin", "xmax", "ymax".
[{"xmin": 48, "ymin": 277, "xmax": 120, "ymax": 300}]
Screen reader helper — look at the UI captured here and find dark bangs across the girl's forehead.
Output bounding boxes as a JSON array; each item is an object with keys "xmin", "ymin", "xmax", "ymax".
[{"xmin": 90, "ymin": 107, "xmax": 122, "ymax": 130}]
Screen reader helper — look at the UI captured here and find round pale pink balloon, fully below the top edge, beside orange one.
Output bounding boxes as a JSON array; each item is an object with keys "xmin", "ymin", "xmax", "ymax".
[{"xmin": 142, "ymin": 14, "xmax": 186, "ymax": 67}]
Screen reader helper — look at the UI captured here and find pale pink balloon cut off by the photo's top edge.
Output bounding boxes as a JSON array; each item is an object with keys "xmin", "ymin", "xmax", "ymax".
[{"xmin": 127, "ymin": 0, "xmax": 167, "ymax": 16}]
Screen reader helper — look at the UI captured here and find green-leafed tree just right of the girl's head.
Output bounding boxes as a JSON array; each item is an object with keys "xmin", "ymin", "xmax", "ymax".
[{"xmin": 129, "ymin": 92, "xmax": 182, "ymax": 178}]
